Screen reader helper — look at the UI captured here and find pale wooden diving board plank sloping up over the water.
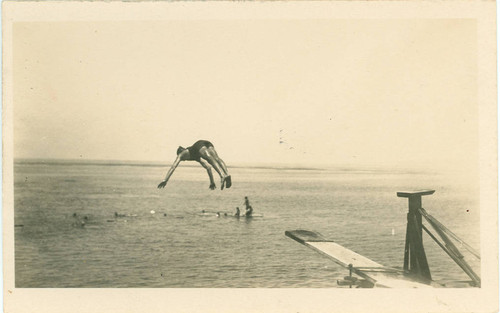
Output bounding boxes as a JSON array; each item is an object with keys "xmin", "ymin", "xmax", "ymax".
[{"xmin": 285, "ymin": 230, "xmax": 432, "ymax": 288}]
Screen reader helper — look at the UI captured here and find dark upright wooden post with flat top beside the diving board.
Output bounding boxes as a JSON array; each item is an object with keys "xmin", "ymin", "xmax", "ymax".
[{"xmin": 397, "ymin": 190, "xmax": 434, "ymax": 282}]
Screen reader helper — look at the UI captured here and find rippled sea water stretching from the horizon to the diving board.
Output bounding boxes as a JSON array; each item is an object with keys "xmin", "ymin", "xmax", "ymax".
[{"xmin": 14, "ymin": 161, "xmax": 480, "ymax": 288}]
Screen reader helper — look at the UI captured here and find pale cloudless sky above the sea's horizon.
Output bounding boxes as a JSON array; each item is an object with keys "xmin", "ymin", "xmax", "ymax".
[{"xmin": 13, "ymin": 19, "xmax": 478, "ymax": 168}]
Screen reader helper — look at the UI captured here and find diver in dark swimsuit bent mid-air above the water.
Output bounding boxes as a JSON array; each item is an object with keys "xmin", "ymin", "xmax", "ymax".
[{"xmin": 158, "ymin": 140, "xmax": 232, "ymax": 190}]
